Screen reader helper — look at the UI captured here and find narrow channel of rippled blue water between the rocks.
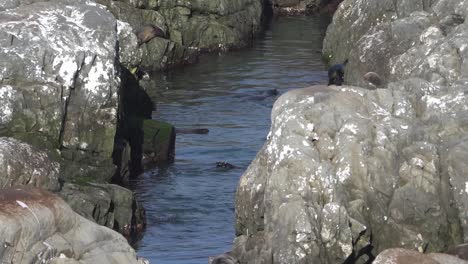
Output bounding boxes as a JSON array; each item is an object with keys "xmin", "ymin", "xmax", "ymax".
[{"xmin": 135, "ymin": 14, "xmax": 328, "ymax": 264}]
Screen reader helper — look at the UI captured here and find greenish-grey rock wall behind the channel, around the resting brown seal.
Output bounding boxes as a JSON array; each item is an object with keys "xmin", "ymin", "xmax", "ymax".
[{"xmin": 98, "ymin": 0, "xmax": 262, "ymax": 70}]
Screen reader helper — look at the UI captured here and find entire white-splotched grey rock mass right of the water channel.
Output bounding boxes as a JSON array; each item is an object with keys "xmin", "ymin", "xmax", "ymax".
[{"xmin": 233, "ymin": 0, "xmax": 468, "ymax": 263}]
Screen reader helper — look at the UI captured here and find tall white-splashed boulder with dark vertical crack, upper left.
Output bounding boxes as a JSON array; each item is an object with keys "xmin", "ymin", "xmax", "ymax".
[{"xmin": 0, "ymin": 2, "xmax": 120, "ymax": 182}]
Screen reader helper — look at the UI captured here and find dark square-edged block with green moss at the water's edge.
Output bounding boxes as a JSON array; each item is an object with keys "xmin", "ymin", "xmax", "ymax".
[{"xmin": 143, "ymin": 119, "xmax": 175, "ymax": 163}]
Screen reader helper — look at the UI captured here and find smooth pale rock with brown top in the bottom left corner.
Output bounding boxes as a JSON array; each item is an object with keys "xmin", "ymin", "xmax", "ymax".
[{"xmin": 0, "ymin": 187, "xmax": 143, "ymax": 264}]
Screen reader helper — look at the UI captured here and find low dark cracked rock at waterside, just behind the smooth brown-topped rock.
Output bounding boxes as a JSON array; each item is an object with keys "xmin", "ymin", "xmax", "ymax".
[{"xmin": 59, "ymin": 182, "xmax": 146, "ymax": 239}]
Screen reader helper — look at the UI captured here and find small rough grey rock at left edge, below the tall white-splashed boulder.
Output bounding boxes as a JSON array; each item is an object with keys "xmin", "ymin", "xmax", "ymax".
[{"xmin": 0, "ymin": 137, "xmax": 60, "ymax": 191}]
